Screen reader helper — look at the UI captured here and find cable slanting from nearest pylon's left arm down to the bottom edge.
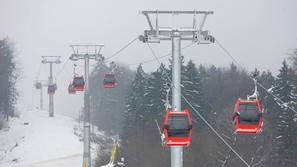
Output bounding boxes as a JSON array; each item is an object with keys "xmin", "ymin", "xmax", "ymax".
[{"xmin": 147, "ymin": 43, "xmax": 250, "ymax": 167}]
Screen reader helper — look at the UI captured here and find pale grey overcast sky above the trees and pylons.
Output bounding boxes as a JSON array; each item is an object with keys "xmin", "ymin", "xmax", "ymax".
[{"xmin": 0, "ymin": 0, "xmax": 297, "ymax": 117}]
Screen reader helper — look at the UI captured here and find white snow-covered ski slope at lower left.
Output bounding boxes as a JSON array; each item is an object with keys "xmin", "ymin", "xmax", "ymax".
[{"xmin": 0, "ymin": 110, "xmax": 83, "ymax": 167}]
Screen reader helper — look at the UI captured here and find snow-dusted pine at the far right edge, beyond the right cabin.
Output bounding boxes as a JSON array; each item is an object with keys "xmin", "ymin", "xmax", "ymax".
[{"xmin": 272, "ymin": 61, "xmax": 297, "ymax": 166}]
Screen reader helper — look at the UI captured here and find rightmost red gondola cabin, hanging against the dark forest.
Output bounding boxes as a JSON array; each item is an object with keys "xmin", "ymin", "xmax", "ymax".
[{"xmin": 233, "ymin": 98, "xmax": 263, "ymax": 134}]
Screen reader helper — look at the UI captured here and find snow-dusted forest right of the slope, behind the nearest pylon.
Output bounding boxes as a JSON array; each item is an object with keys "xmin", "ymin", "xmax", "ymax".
[{"xmin": 91, "ymin": 50, "xmax": 297, "ymax": 167}]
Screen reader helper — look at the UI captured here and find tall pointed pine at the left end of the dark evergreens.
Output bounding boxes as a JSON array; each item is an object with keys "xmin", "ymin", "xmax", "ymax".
[{"xmin": 122, "ymin": 65, "xmax": 148, "ymax": 165}]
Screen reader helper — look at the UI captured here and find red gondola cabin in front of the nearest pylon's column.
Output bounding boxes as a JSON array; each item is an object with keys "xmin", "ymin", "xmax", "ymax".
[{"xmin": 163, "ymin": 109, "xmax": 192, "ymax": 146}]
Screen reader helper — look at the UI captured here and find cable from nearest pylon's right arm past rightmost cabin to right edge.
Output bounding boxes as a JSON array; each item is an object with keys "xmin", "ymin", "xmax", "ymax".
[{"xmin": 216, "ymin": 39, "xmax": 297, "ymax": 114}]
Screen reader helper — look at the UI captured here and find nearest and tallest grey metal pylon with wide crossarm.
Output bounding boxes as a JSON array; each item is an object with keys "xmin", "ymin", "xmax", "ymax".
[{"xmin": 139, "ymin": 11, "xmax": 214, "ymax": 167}]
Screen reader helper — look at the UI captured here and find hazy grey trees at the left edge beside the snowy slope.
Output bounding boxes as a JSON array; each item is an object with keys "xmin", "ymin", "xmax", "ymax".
[{"xmin": 0, "ymin": 39, "xmax": 19, "ymax": 128}]
